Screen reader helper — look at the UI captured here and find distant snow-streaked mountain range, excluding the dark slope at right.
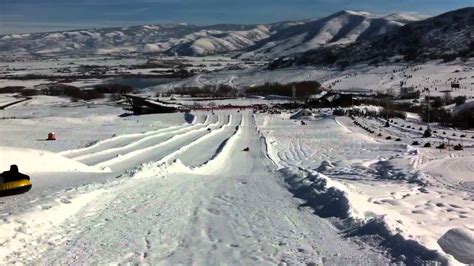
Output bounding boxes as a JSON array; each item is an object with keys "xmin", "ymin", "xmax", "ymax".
[{"xmin": 0, "ymin": 11, "xmax": 410, "ymax": 58}]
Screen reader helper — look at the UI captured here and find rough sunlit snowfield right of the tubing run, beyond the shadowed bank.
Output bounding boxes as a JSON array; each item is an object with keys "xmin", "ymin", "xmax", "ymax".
[{"xmin": 258, "ymin": 111, "xmax": 474, "ymax": 264}]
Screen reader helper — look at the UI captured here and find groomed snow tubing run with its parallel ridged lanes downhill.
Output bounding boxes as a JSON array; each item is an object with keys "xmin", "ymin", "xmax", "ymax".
[{"xmin": 0, "ymin": 112, "xmax": 389, "ymax": 265}]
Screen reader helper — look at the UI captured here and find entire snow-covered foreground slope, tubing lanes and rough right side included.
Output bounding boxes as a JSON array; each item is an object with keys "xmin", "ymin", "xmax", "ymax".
[{"xmin": 0, "ymin": 93, "xmax": 474, "ymax": 265}]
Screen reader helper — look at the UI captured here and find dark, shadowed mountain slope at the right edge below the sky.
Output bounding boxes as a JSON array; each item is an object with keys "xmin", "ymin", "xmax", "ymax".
[{"xmin": 271, "ymin": 7, "xmax": 474, "ymax": 67}]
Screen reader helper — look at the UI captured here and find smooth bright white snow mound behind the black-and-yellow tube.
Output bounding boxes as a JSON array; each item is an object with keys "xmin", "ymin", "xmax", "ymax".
[{"xmin": 0, "ymin": 147, "xmax": 105, "ymax": 174}]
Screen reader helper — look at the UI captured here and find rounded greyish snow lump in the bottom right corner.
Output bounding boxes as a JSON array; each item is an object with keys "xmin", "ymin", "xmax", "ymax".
[{"xmin": 438, "ymin": 228, "xmax": 474, "ymax": 264}]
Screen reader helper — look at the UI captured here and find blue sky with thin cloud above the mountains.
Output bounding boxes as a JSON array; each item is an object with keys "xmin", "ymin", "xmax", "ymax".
[{"xmin": 0, "ymin": 0, "xmax": 473, "ymax": 34}]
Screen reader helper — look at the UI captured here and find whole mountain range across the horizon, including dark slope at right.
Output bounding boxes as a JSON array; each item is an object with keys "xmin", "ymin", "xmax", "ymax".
[{"xmin": 0, "ymin": 8, "xmax": 474, "ymax": 67}]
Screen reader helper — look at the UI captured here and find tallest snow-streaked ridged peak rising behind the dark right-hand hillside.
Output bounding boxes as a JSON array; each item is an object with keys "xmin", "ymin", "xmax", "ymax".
[{"xmin": 242, "ymin": 11, "xmax": 416, "ymax": 57}]
